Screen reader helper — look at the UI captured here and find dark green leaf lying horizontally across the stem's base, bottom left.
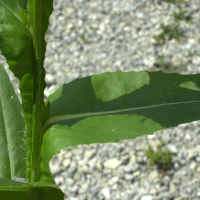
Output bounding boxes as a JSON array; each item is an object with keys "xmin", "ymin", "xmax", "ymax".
[{"xmin": 0, "ymin": 178, "xmax": 64, "ymax": 200}]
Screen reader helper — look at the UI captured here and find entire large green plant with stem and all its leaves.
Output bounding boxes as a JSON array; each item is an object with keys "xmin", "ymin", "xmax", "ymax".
[{"xmin": 0, "ymin": 0, "xmax": 200, "ymax": 200}]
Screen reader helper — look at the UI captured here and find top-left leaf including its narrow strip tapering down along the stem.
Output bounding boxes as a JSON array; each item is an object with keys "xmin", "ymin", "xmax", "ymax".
[{"xmin": 0, "ymin": 0, "xmax": 37, "ymax": 181}]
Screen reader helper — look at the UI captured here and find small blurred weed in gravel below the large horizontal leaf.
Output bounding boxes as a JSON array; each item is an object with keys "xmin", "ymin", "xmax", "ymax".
[{"xmin": 144, "ymin": 139, "xmax": 171, "ymax": 170}]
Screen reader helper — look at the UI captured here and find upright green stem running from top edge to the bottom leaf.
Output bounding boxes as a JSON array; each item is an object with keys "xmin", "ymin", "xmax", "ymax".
[{"xmin": 30, "ymin": 0, "xmax": 45, "ymax": 183}]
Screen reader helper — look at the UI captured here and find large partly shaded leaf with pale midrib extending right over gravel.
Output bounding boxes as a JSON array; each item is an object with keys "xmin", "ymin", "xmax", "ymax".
[{"xmin": 41, "ymin": 71, "xmax": 200, "ymax": 181}]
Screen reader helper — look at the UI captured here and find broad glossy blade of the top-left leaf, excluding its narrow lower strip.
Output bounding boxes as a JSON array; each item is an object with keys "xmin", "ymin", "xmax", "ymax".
[{"xmin": 0, "ymin": 0, "xmax": 36, "ymax": 80}]
